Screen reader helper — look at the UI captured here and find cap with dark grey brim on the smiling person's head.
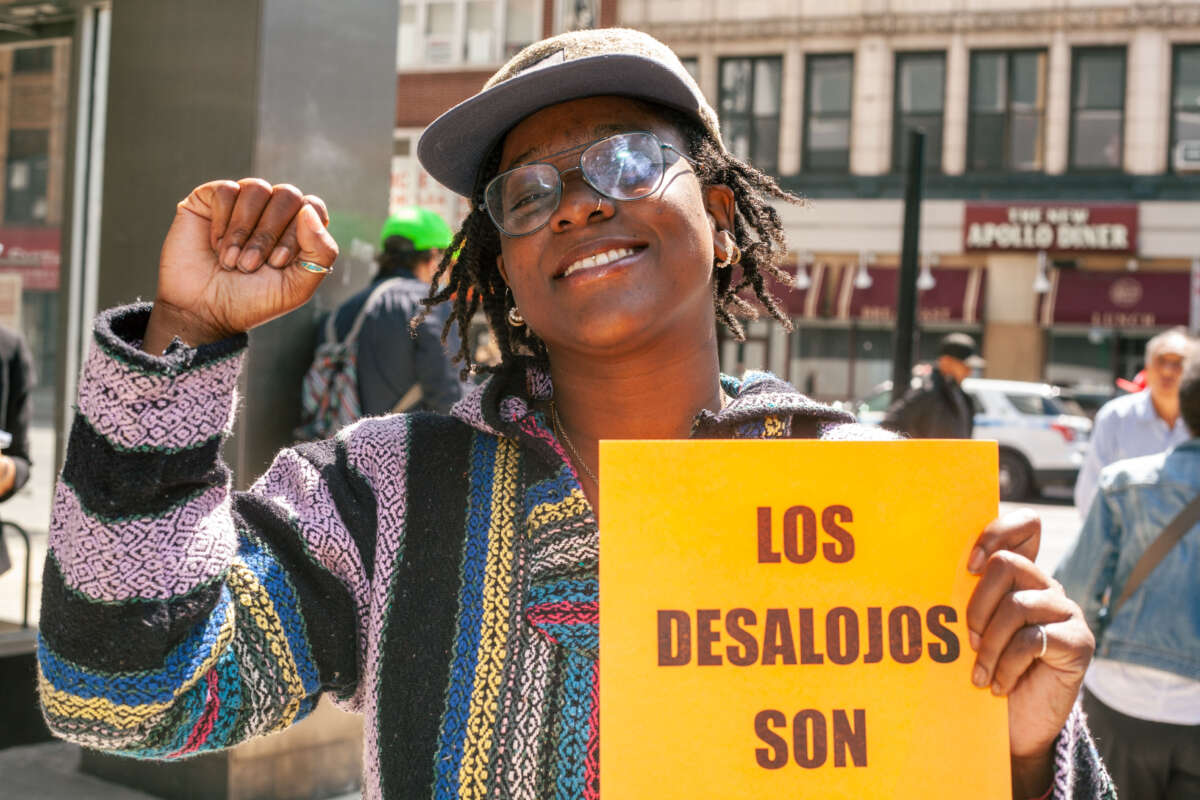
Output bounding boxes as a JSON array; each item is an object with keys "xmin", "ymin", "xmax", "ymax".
[{"xmin": 416, "ymin": 28, "xmax": 725, "ymax": 197}]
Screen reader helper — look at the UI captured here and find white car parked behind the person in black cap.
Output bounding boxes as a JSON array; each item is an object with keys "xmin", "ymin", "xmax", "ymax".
[{"xmin": 851, "ymin": 378, "xmax": 1092, "ymax": 500}]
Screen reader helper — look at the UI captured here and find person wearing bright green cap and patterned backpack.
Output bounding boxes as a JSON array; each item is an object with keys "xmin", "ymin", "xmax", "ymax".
[{"xmin": 321, "ymin": 205, "xmax": 463, "ymax": 416}]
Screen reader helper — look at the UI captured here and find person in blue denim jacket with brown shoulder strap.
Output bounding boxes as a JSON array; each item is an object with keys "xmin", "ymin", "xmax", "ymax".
[{"xmin": 1055, "ymin": 345, "xmax": 1200, "ymax": 800}]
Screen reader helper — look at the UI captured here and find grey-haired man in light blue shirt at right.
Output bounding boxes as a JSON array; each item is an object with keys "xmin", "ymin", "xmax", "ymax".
[{"xmin": 1075, "ymin": 327, "xmax": 1190, "ymax": 513}]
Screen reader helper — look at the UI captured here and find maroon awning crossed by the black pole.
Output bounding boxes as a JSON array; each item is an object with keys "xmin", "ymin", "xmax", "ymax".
[{"xmin": 836, "ymin": 264, "xmax": 985, "ymax": 325}]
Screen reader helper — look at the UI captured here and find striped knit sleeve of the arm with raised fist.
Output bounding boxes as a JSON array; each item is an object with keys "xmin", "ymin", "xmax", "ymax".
[{"xmin": 38, "ymin": 305, "xmax": 373, "ymax": 758}]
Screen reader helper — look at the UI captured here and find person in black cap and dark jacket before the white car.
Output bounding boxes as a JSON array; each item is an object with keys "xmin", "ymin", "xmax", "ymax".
[{"xmin": 883, "ymin": 333, "xmax": 984, "ymax": 439}]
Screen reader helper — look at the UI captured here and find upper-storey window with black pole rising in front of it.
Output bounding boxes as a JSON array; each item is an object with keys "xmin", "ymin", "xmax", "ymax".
[{"xmin": 892, "ymin": 53, "xmax": 946, "ymax": 172}]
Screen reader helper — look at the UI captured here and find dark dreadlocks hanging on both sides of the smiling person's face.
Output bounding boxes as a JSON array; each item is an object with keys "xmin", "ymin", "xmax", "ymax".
[{"xmin": 413, "ymin": 101, "xmax": 803, "ymax": 379}]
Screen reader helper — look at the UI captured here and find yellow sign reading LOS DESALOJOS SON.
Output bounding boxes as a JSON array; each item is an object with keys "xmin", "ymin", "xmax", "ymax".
[{"xmin": 600, "ymin": 440, "xmax": 1010, "ymax": 800}]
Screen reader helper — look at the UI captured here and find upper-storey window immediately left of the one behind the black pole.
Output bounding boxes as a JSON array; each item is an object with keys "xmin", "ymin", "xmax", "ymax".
[{"xmin": 802, "ymin": 55, "xmax": 854, "ymax": 173}]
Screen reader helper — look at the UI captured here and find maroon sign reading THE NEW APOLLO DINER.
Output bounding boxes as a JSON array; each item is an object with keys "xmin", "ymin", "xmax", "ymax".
[{"xmin": 962, "ymin": 203, "xmax": 1138, "ymax": 253}]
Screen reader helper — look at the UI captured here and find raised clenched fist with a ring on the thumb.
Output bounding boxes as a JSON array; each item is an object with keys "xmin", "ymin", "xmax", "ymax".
[{"xmin": 143, "ymin": 178, "xmax": 337, "ymax": 355}]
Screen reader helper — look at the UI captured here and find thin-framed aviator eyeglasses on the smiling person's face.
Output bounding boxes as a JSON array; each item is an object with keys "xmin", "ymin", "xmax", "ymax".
[{"xmin": 482, "ymin": 131, "xmax": 695, "ymax": 237}]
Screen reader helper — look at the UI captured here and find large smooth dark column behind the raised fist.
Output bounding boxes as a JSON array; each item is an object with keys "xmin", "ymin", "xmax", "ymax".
[{"xmin": 83, "ymin": 0, "xmax": 398, "ymax": 800}]
